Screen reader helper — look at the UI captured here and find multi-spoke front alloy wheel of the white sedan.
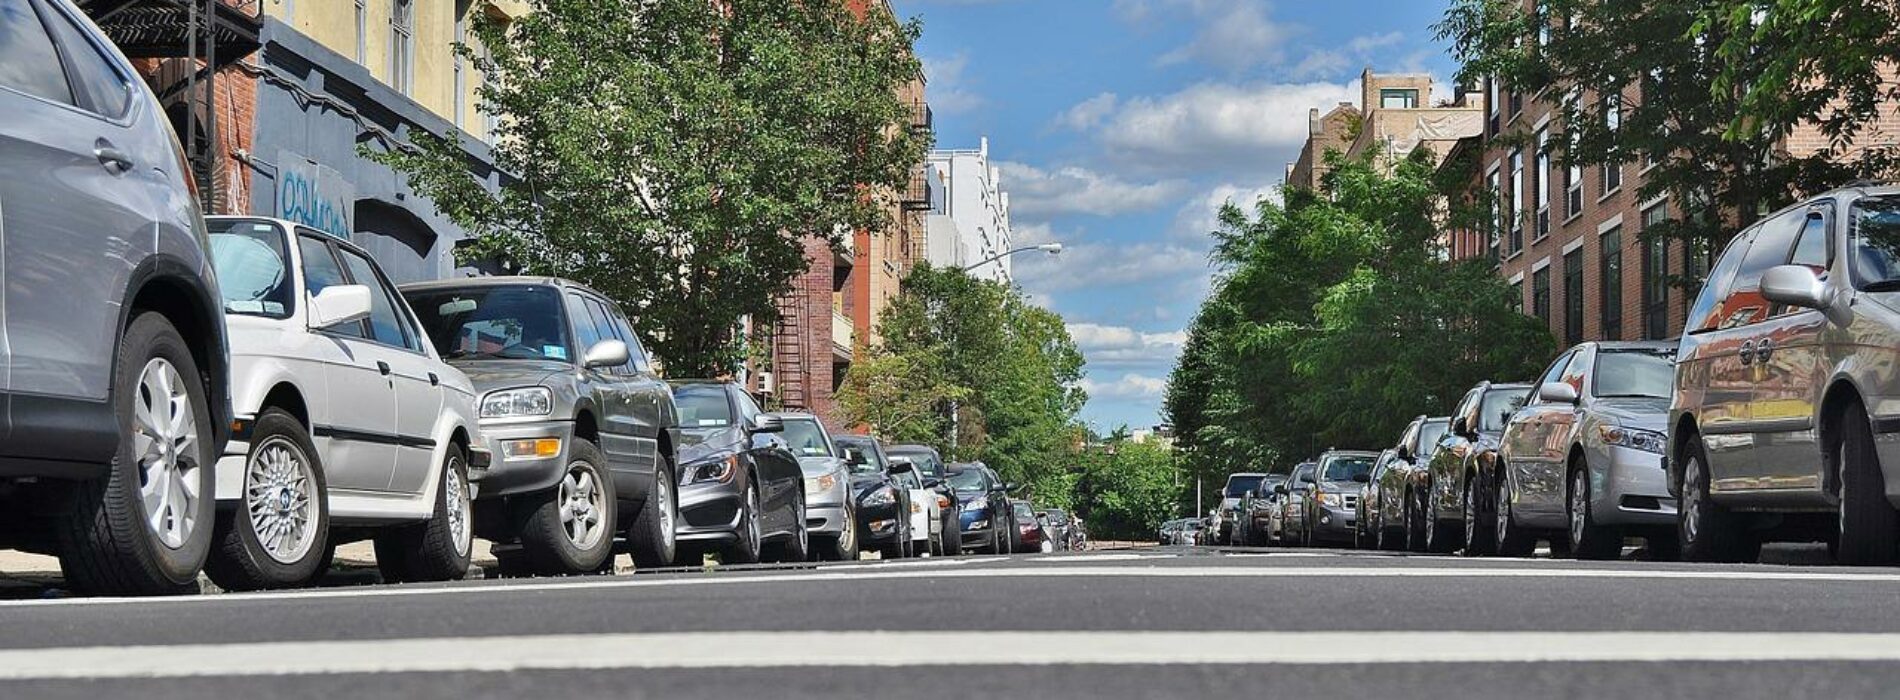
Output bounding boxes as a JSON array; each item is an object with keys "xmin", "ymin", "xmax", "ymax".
[{"xmin": 245, "ymin": 436, "xmax": 317, "ymax": 565}]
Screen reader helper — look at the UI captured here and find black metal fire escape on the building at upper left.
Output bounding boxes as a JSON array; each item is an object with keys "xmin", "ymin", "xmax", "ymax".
[{"xmin": 78, "ymin": 0, "xmax": 262, "ymax": 213}]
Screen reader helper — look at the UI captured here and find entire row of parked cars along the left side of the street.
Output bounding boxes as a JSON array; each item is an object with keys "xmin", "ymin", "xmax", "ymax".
[{"xmin": 0, "ymin": 0, "xmax": 1068, "ymax": 595}]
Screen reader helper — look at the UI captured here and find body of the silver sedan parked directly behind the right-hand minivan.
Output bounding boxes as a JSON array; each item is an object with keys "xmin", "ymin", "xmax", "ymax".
[{"xmin": 1499, "ymin": 342, "xmax": 1676, "ymax": 529}]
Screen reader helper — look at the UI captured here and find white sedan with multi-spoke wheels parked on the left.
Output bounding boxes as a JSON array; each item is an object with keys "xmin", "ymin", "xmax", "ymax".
[{"xmin": 205, "ymin": 217, "xmax": 488, "ymax": 590}]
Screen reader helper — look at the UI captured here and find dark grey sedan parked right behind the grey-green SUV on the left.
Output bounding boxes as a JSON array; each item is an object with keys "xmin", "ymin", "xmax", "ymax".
[{"xmin": 673, "ymin": 380, "xmax": 811, "ymax": 563}]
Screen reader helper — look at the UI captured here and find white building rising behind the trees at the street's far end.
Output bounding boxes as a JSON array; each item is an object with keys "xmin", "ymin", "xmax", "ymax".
[{"xmin": 923, "ymin": 137, "xmax": 1015, "ymax": 283}]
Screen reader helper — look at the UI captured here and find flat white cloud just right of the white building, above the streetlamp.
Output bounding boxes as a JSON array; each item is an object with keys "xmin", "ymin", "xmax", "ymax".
[{"xmin": 998, "ymin": 162, "xmax": 1188, "ymax": 217}]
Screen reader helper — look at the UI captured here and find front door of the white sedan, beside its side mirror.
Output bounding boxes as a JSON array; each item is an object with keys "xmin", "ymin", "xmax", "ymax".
[{"xmin": 296, "ymin": 230, "xmax": 397, "ymax": 491}]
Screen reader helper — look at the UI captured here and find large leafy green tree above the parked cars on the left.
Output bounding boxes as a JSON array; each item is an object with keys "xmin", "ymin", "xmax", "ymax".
[{"xmin": 372, "ymin": 0, "xmax": 929, "ymax": 377}]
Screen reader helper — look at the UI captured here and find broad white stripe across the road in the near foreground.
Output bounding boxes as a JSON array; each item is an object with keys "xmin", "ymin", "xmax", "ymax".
[{"xmin": 11, "ymin": 632, "xmax": 1900, "ymax": 681}]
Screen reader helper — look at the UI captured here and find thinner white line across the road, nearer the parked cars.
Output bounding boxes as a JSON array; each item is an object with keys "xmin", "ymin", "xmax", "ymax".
[{"xmin": 0, "ymin": 561, "xmax": 1900, "ymax": 609}]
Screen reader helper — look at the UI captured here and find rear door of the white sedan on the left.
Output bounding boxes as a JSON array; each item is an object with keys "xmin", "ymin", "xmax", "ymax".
[{"xmin": 336, "ymin": 245, "xmax": 443, "ymax": 495}]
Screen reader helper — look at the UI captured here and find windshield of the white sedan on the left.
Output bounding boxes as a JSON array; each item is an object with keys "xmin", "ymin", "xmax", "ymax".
[{"xmin": 205, "ymin": 219, "xmax": 296, "ymax": 318}]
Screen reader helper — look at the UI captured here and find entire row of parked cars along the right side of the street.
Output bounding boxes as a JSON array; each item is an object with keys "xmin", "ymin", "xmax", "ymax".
[{"xmin": 1208, "ymin": 185, "xmax": 1900, "ymax": 563}]
